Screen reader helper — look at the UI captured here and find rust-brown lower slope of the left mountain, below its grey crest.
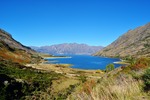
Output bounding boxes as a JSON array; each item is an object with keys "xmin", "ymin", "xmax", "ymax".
[{"xmin": 0, "ymin": 41, "xmax": 42, "ymax": 64}]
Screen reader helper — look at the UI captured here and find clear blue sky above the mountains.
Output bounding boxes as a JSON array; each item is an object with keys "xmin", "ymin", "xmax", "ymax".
[{"xmin": 0, "ymin": 0, "xmax": 150, "ymax": 46}]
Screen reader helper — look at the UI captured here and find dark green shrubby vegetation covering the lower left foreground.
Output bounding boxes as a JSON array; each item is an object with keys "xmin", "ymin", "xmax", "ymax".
[{"xmin": 0, "ymin": 60, "xmax": 62, "ymax": 100}]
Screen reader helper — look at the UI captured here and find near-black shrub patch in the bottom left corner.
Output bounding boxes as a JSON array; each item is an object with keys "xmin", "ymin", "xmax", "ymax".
[{"xmin": 0, "ymin": 74, "xmax": 30, "ymax": 100}]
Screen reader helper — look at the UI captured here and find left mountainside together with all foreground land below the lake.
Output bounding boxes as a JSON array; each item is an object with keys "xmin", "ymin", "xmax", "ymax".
[{"xmin": 0, "ymin": 27, "xmax": 150, "ymax": 100}]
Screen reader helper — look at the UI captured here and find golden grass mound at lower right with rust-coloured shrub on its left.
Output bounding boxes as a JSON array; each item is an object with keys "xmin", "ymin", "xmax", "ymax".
[{"xmin": 68, "ymin": 69, "xmax": 149, "ymax": 100}]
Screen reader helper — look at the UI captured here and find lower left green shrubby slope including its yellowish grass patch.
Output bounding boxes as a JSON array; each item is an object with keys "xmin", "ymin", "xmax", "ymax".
[{"xmin": 0, "ymin": 59, "xmax": 79, "ymax": 100}]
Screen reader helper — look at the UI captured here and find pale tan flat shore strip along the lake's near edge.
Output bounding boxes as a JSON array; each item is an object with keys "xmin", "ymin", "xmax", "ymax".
[{"xmin": 26, "ymin": 63, "xmax": 104, "ymax": 79}]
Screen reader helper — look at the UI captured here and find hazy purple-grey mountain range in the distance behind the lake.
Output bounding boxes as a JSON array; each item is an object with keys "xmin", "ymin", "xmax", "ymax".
[{"xmin": 31, "ymin": 43, "xmax": 103, "ymax": 55}]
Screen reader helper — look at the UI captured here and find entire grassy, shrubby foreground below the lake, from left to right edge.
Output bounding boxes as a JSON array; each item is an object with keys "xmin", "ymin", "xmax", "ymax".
[{"xmin": 0, "ymin": 48, "xmax": 150, "ymax": 100}]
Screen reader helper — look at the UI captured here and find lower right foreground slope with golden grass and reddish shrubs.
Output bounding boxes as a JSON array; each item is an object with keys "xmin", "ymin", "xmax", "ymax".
[{"xmin": 68, "ymin": 58, "xmax": 150, "ymax": 100}]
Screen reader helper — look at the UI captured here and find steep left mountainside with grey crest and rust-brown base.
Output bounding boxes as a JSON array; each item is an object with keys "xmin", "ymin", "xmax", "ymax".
[{"xmin": 0, "ymin": 29, "xmax": 41, "ymax": 63}]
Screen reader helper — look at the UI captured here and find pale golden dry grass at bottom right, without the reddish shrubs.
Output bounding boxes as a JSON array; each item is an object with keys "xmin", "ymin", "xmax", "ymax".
[{"xmin": 70, "ymin": 79, "xmax": 148, "ymax": 100}]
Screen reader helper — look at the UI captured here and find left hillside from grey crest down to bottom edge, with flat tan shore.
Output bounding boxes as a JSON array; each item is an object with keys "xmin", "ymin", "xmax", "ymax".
[{"xmin": 0, "ymin": 30, "xmax": 102, "ymax": 100}]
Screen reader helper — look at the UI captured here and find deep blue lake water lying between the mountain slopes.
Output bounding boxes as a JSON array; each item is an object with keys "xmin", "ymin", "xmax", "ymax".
[{"xmin": 47, "ymin": 55, "xmax": 121, "ymax": 70}]
